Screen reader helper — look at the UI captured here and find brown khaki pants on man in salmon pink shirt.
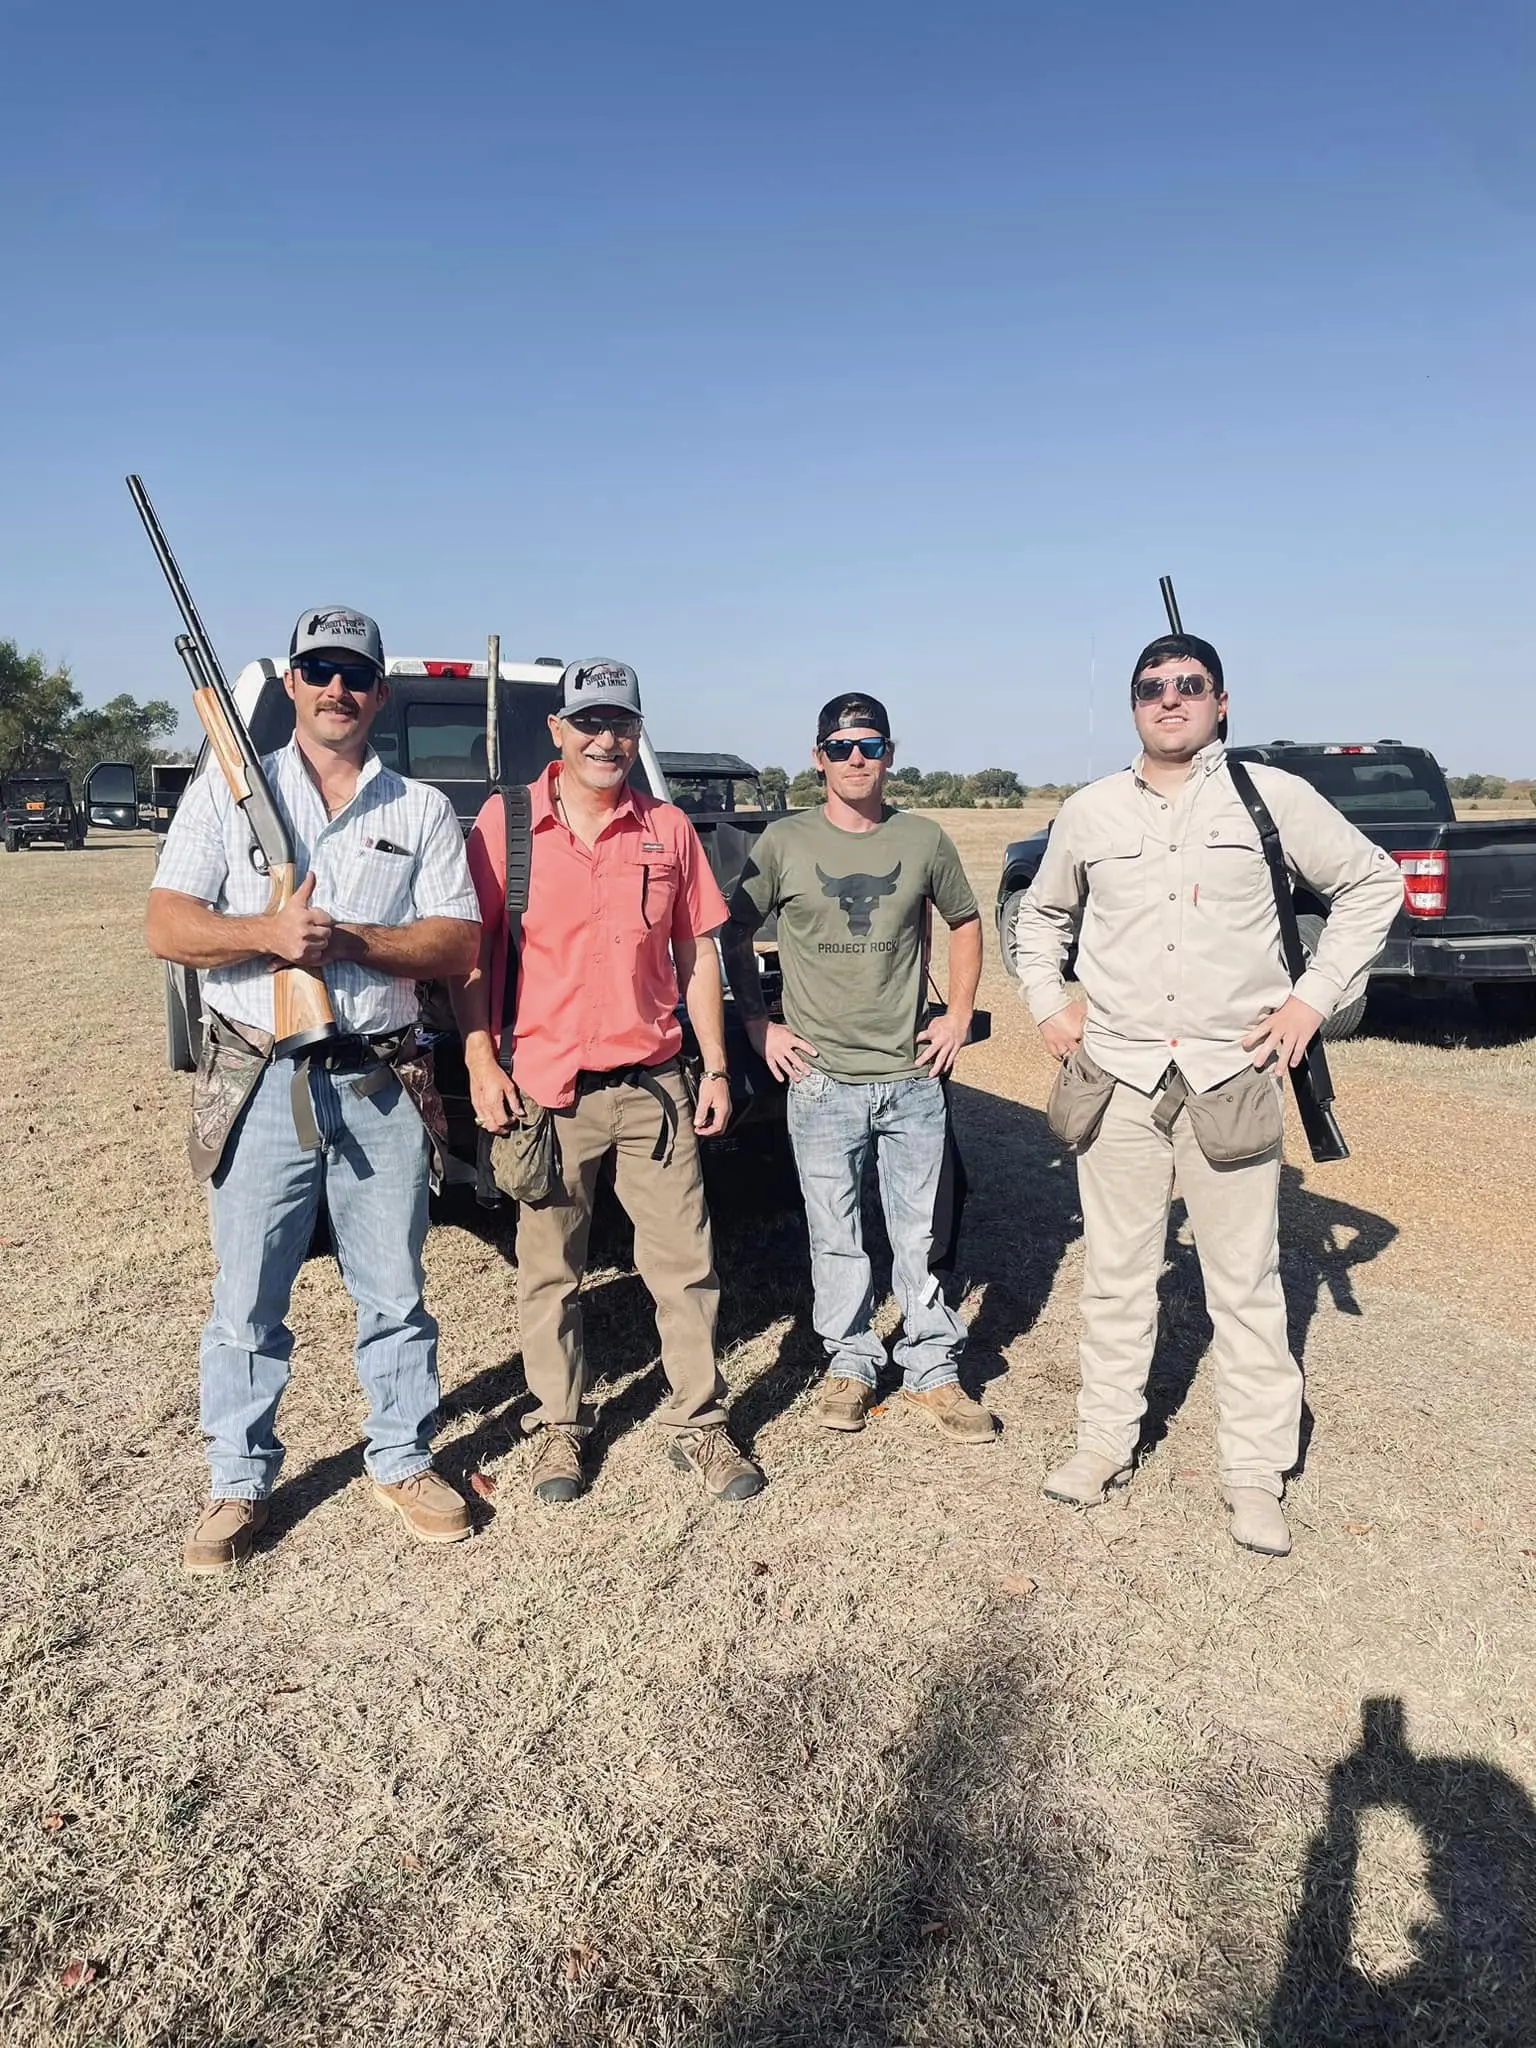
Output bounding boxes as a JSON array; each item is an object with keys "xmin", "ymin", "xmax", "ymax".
[{"xmin": 518, "ymin": 1061, "xmax": 725, "ymax": 1430}]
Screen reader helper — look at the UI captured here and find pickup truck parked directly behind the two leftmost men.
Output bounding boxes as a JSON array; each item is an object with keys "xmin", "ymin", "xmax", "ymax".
[{"xmin": 166, "ymin": 659, "xmax": 784, "ymax": 1182}]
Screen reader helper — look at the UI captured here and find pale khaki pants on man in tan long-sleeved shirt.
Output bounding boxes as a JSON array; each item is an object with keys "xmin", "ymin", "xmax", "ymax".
[{"xmin": 1077, "ymin": 1081, "xmax": 1303, "ymax": 1497}]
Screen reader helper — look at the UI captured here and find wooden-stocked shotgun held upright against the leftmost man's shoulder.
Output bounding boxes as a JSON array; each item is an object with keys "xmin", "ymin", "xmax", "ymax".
[{"xmin": 127, "ymin": 477, "xmax": 340, "ymax": 1059}]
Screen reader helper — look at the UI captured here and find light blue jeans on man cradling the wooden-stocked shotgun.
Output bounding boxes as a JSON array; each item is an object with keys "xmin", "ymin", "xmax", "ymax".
[{"xmin": 203, "ymin": 1061, "xmax": 438, "ymax": 1501}]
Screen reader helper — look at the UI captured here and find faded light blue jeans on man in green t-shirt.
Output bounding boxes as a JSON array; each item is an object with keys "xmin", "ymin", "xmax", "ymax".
[{"xmin": 788, "ymin": 1073, "xmax": 965, "ymax": 1393}]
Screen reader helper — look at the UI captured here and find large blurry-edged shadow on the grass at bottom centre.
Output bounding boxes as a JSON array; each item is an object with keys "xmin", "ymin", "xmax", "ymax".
[{"xmin": 698, "ymin": 1620, "xmax": 1096, "ymax": 2048}]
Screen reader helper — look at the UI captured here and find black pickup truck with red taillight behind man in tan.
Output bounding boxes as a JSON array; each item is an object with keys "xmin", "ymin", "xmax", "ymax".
[{"xmin": 997, "ymin": 739, "xmax": 1536, "ymax": 1038}]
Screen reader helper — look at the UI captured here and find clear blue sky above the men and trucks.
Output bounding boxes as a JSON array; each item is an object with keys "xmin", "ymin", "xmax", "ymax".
[{"xmin": 0, "ymin": 0, "xmax": 1536, "ymax": 780}]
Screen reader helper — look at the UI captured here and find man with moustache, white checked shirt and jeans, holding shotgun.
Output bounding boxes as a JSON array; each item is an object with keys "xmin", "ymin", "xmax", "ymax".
[{"xmin": 145, "ymin": 606, "xmax": 479, "ymax": 1573}]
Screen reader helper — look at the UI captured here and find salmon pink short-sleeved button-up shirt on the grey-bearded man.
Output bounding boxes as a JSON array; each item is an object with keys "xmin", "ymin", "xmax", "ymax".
[{"xmin": 467, "ymin": 764, "xmax": 727, "ymax": 1110}]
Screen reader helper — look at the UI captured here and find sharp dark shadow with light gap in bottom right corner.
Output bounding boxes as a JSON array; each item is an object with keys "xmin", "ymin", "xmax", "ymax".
[{"xmin": 1262, "ymin": 1698, "xmax": 1536, "ymax": 2048}]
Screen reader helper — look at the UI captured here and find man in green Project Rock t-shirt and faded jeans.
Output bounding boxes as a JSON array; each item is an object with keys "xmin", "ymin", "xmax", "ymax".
[{"xmin": 721, "ymin": 692, "xmax": 997, "ymax": 1444}]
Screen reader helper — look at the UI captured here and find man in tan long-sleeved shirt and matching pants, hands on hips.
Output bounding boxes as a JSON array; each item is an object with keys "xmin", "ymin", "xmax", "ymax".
[{"xmin": 1016, "ymin": 633, "xmax": 1403, "ymax": 1556}]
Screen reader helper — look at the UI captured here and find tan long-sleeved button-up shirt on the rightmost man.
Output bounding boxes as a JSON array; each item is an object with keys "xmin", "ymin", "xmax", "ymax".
[{"xmin": 1014, "ymin": 739, "xmax": 1403, "ymax": 1094}]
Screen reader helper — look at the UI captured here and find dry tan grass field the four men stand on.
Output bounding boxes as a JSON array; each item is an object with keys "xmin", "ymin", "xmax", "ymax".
[{"xmin": 0, "ymin": 811, "xmax": 1536, "ymax": 2048}]
